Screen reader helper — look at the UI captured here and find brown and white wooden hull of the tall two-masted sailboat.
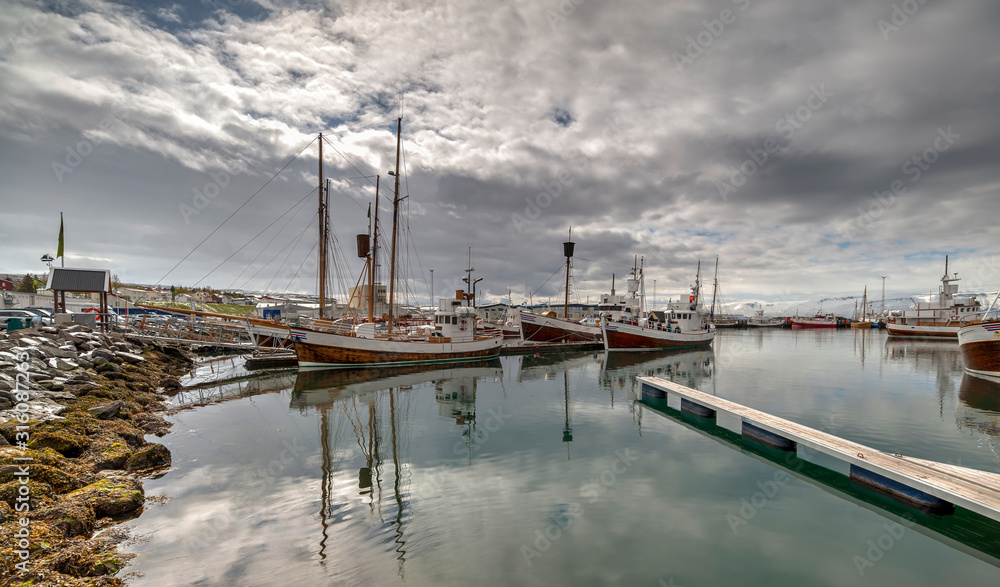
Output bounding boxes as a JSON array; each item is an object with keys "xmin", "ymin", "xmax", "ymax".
[{"xmin": 292, "ymin": 328, "xmax": 503, "ymax": 368}]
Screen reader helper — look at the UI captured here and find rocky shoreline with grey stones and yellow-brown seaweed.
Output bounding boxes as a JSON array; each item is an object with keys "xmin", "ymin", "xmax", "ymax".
[{"xmin": 0, "ymin": 323, "xmax": 192, "ymax": 586}]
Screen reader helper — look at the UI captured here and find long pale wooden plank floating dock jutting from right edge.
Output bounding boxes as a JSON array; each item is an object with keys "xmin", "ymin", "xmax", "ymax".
[{"xmin": 636, "ymin": 377, "xmax": 1000, "ymax": 521}]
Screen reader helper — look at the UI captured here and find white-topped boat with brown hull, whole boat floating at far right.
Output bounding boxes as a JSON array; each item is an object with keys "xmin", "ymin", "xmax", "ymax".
[{"xmin": 886, "ymin": 256, "xmax": 982, "ymax": 339}]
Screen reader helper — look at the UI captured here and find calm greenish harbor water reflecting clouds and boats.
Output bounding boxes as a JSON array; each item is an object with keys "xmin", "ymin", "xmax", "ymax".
[{"xmin": 125, "ymin": 329, "xmax": 1000, "ymax": 586}]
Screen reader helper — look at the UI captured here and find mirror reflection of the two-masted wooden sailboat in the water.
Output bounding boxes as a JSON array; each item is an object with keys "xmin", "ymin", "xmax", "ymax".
[{"xmin": 291, "ymin": 359, "xmax": 503, "ymax": 581}]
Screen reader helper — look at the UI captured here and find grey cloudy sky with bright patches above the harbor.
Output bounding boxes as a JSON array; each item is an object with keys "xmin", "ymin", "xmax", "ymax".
[{"xmin": 0, "ymin": 0, "xmax": 1000, "ymax": 302}]
